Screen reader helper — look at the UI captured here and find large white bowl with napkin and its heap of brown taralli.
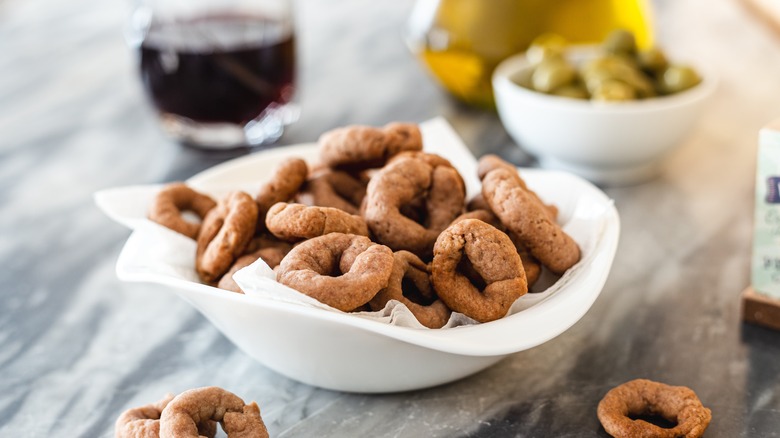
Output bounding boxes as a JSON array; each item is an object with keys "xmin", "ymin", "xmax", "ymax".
[{"xmin": 95, "ymin": 119, "xmax": 620, "ymax": 393}]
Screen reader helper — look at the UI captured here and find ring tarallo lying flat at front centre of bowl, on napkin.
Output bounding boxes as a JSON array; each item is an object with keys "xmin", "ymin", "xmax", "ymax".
[{"xmin": 276, "ymin": 233, "xmax": 393, "ymax": 312}]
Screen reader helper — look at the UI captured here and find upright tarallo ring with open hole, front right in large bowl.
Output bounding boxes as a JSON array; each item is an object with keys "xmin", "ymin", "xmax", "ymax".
[{"xmin": 431, "ymin": 219, "xmax": 528, "ymax": 322}]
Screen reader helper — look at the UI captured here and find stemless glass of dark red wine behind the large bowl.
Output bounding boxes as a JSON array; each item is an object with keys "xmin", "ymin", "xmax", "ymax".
[{"xmin": 128, "ymin": 0, "xmax": 298, "ymax": 149}]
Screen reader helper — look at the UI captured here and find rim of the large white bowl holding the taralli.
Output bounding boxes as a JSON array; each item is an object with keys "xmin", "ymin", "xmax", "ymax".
[{"xmin": 106, "ymin": 144, "xmax": 620, "ymax": 356}]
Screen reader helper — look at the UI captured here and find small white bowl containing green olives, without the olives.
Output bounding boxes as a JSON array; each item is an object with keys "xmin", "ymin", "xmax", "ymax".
[{"xmin": 493, "ymin": 47, "xmax": 715, "ymax": 185}]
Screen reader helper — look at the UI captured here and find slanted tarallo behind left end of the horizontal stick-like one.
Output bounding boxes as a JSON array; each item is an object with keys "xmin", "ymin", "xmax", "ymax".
[{"xmin": 255, "ymin": 158, "xmax": 309, "ymax": 229}]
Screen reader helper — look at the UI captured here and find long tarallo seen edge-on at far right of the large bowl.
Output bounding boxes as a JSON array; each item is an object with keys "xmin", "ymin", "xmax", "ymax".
[{"xmin": 482, "ymin": 169, "xmax": 580, "ymax": 274}]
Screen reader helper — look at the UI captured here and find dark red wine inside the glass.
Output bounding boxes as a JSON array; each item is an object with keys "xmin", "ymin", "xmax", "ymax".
[{"xmin": 141, "ymin": 16, "xmax": 295, "ymax": 125}]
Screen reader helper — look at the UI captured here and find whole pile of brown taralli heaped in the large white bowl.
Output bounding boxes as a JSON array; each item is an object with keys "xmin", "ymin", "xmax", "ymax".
[{"xmin": 149, "ymin": 123, "xmax": 580, "ymax": 328}]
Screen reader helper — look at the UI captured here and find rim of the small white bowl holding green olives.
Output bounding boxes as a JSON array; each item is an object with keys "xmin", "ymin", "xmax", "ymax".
[{"xmin": 492, "ymin": 45, "xmax": 717, "ymax": 115}]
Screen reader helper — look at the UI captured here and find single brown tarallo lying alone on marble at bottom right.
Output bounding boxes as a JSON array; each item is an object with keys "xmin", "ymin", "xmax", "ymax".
[{"xmin": 597, "ymin": 379, "xmax": 712, "ymax": 438}]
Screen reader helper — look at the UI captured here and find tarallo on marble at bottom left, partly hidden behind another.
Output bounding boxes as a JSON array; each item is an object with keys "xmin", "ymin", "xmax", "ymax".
[{"xmin": 114, "ymin": 394, "xmax": 217, "ymax": 438}]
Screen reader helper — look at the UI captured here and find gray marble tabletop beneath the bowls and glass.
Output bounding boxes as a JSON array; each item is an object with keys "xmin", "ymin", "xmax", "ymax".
[{"xmin": 0, "ymin": 0, "xmax": 780, "ymax": 438}]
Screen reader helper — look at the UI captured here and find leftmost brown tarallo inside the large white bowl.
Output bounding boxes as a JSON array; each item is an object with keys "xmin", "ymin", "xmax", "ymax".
[{"xmin": 149, "ymin": 183, "xmax": 217, "ymax": 239}]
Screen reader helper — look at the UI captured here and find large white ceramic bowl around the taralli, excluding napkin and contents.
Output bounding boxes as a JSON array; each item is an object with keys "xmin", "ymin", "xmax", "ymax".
[{"xmin": 96, "ymin": 121, "xmax": 620, "ymax": 393}]
